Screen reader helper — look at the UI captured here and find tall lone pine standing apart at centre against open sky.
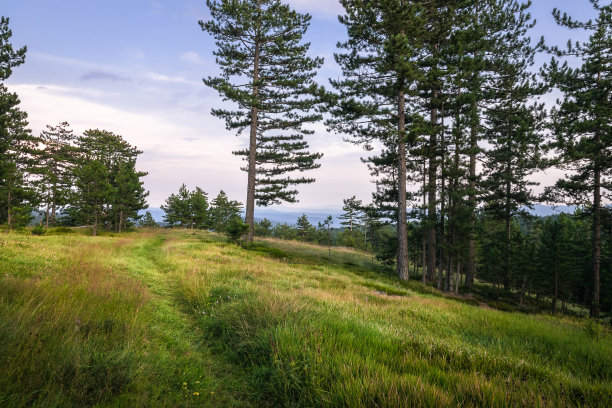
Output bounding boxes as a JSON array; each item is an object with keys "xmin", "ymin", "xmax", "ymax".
[{"xmin": 200, "ymin": 0, "xmax": 323, "ymax": 242}]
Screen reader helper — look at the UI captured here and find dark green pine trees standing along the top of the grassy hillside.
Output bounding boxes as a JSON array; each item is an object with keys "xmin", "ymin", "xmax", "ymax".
[{"xmin": 0, "ymin": 0, "xmax": 612, "ymax": 317}]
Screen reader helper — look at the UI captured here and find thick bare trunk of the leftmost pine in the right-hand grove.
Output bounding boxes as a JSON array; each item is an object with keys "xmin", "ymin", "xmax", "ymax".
[{"xmin": 397, "ymin": 90, "xmax": 410, "ymax": 281}]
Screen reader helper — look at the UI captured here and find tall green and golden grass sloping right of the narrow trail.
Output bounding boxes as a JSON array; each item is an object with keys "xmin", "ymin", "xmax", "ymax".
[{"xmin": 169, "ymin": 231, "xmax": 612, "ymax": 407}]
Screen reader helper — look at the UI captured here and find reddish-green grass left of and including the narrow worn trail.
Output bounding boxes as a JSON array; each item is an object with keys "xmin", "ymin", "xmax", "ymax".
[{"xmin": 0, "ymin": 231, "xmax": 249, "ymax": 407}]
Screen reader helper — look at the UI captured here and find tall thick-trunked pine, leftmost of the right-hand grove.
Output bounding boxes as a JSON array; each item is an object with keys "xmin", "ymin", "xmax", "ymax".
[{"xmin": 329, "ymin": 0, "xmax": 424, "ymax": 280}]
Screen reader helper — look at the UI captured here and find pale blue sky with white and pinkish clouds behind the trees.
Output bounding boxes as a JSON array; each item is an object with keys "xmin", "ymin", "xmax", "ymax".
[{"xmin": 0, "ymin": 0, "xmax": 593, "ymax": 211}]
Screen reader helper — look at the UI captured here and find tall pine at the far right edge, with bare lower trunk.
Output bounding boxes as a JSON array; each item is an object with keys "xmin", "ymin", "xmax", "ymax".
[{"xmin": 545, "ymin": 0, "xmax": 612, "ymax": 317}]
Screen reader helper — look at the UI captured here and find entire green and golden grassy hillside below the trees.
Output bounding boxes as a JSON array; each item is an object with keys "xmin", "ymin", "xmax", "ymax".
[{"xmin": 0, "ymin": 231, "xmax": 612, "ymax": 407}]
